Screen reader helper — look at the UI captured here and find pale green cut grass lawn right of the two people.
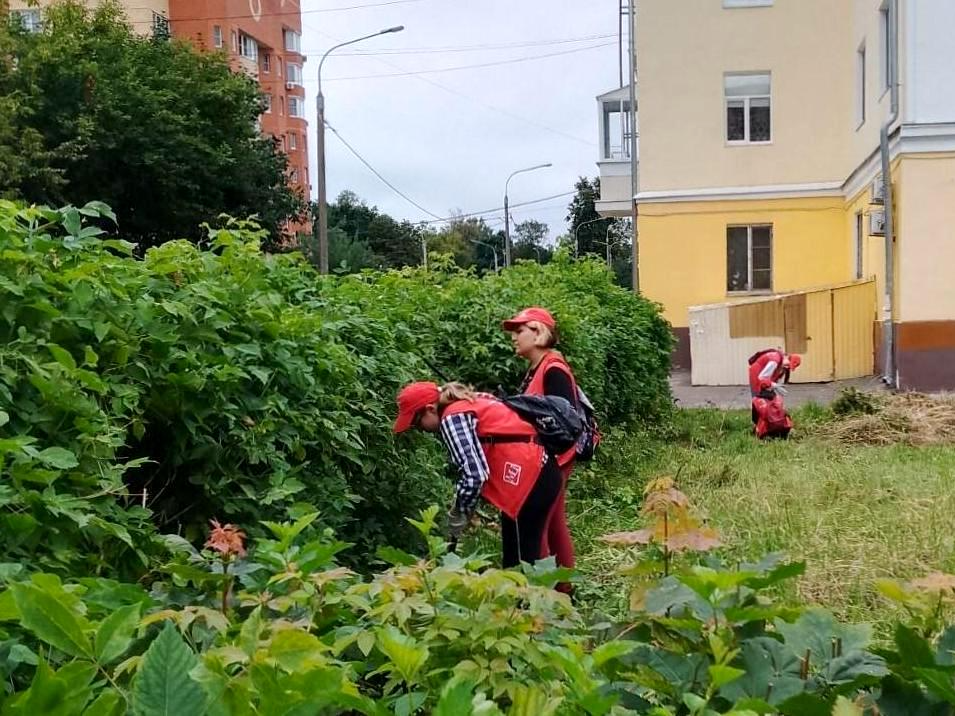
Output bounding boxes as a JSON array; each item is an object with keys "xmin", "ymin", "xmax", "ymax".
[{"xmin": 569, "ymin": 406, "xmax": 955, "ymax": 634}]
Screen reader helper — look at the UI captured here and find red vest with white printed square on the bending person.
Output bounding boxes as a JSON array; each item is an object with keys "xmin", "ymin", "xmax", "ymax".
[{"xmin": 441, "ymin": 397, "xmax": 545, "ymax": 520}]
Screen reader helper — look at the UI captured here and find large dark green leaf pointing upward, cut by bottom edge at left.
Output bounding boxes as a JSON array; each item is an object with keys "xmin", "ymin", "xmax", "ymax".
[{"xmin": 133, "ymin": 623, "xmax": 206, "ymax": 716}]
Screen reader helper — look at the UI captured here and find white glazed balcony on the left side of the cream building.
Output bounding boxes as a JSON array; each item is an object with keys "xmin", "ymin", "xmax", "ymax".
[{"xmin": 596, "ymin": 87, "xmax": 639, "ymax": 216}]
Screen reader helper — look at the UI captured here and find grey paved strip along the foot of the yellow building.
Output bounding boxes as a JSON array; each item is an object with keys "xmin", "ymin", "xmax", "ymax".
[{"xmin": 670, "ymin": 371, "xmax": 885, "ymax": 410}]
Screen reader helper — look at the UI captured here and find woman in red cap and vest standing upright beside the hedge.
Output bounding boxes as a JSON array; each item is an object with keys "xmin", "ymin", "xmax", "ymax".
[{"xmin": 503, "ymin": 307, "xmax": 578, "ymax": 592}]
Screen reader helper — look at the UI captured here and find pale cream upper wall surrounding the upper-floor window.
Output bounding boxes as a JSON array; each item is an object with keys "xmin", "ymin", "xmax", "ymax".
[{"xmin": 636, "ymin": 0, "xmax": 856, "ymax": 192}]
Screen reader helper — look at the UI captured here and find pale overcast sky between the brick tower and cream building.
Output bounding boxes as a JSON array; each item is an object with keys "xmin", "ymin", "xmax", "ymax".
[{"xmin": 302, "ymin": 0, "xmax": 618, "ymax": 239}]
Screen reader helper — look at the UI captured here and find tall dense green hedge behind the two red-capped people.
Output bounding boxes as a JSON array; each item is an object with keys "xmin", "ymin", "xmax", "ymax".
[{"xmin": 0, "ymin": 203, "xmax": 669, "ymax": 576}]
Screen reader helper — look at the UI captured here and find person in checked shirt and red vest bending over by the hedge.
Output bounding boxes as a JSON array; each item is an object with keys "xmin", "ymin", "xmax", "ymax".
[{"xmin": 394, "ymin": 382, "xmax": 561, "ymax": 568}]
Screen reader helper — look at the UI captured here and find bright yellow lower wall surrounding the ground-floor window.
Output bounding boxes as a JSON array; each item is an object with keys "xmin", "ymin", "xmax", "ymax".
[{"xmin": 638, "ymin": 197, "xmax": 852, "ymax": 327}]
